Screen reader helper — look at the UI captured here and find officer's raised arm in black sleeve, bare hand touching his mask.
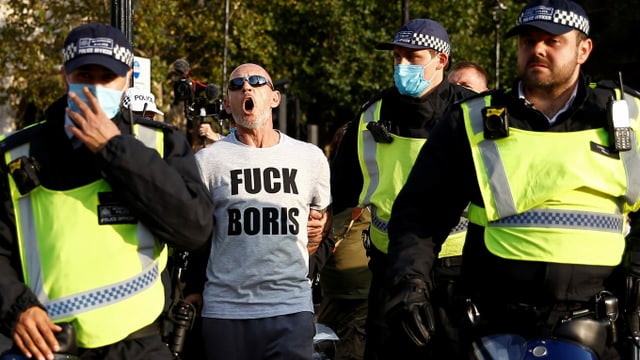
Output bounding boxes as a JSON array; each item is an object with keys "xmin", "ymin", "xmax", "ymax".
[{"xmin": 66, "ymin": 88, "xmax": 213, "ymax": 249}]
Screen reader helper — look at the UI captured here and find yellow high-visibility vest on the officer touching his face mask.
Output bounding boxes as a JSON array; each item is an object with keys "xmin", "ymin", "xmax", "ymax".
[{"xmin": 4, "ymin": 125, "xmax": 167, "ymax": 348}]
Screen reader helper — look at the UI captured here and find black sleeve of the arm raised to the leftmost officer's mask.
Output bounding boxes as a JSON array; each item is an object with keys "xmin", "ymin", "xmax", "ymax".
[{"xmin": 99, "ymin": 125, "xmax": 213, "ymax": 250}]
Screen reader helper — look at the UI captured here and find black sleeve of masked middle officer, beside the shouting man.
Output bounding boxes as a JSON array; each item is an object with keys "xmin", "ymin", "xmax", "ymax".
[{"xmin": 331, "ymin": 120, "xmax": 364, "ymax": 214}]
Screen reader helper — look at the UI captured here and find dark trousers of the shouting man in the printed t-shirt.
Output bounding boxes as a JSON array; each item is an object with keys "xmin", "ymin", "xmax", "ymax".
[{"xmin": 202, "ymin": 312, "xmax": 316, "ymax": 360}]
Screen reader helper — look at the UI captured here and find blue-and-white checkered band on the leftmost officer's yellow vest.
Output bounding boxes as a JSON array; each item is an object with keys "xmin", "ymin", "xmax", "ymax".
[{"xmin": 46, "ymin": 265, "xmax": 158, "ymax": 319}]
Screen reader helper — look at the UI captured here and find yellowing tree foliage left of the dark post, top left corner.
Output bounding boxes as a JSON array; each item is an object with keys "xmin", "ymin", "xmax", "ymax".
[{"xmin": 0, "ymin": 0, "xmax": 109, "ymax": 127}]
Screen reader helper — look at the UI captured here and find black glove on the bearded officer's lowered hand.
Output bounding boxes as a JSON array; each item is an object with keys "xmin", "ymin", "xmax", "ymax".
[{"xmin": 384, "ymin": 278, "xmax": 435, "ymax": 346}]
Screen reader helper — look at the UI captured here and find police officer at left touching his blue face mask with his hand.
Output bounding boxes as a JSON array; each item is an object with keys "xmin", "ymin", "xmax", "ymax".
[{"xmin": 0, "ymin": 23, "xmax": 213, "ymax": 360}]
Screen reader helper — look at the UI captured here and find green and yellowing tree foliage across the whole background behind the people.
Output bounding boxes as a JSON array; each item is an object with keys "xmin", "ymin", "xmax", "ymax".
[{"xmin": 0, "ymin": 0, "xmax": 640, "ymax": 143}]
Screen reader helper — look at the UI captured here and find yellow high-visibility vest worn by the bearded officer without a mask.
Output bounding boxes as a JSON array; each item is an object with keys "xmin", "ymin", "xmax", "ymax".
[{"xmin": 462, "ymin": 91, "xmax": 640, "ymax": 266}]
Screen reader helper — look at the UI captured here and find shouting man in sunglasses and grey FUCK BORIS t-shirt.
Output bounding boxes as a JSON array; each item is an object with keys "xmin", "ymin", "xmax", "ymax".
[{"xmin": 196, "ymin": 64, "xmax": 330, "ymax": 360}]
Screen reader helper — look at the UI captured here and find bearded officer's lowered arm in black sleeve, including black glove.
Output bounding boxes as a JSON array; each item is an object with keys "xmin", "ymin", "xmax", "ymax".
[{"xmin": 385, "ymin": 107, "xmax": 475, "ymax": 346}]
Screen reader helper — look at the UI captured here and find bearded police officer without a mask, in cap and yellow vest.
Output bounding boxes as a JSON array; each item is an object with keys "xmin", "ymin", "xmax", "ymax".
[{"xmin": 389, "ymin": 0, "xmax": 640, "ymax": 359}]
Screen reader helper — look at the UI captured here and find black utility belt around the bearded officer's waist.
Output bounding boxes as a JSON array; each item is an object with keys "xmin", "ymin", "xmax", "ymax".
[{"xmin": 466, "ymin": 291, "xmax": 619, "ymax": 356}]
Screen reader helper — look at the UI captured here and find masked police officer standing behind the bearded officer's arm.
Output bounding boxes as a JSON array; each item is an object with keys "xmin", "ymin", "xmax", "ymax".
[{"xmin": 330, "ymin": 19, "xmax": 473, "ymax": 359}]
